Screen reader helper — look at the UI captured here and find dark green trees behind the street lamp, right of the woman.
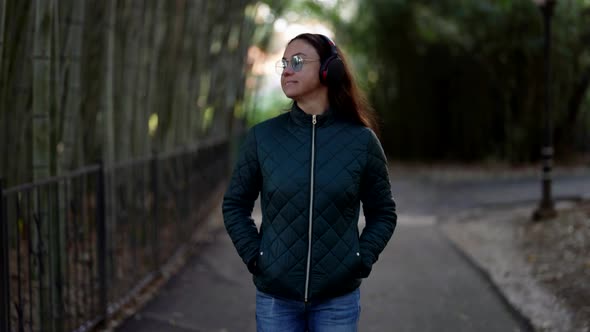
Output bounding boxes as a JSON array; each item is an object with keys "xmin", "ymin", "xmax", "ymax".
[{"xmin": 328, "ymin": 0, "xmax": 590, "ymax": 163}]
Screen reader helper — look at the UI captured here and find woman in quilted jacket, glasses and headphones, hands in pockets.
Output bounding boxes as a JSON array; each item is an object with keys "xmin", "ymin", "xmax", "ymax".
[{"xmin": 223, "ymin": 34, "xmax": 397, "ymax": 332}]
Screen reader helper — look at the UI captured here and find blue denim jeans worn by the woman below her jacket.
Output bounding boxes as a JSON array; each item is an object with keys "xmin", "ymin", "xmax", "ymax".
[{"xmin": 256, "ymin": 289, "xmax": 361, "ymax": 332}]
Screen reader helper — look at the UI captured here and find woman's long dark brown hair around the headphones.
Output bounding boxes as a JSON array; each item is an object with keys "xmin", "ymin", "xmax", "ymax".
[{"xmin": 288, "ymin": 33, "xmax": 379, "ymax": 136}]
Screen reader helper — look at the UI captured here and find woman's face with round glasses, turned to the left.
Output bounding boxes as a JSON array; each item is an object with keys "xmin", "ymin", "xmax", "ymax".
[{"xmin": 281, "ymin": 39, "xmax": 325, "ymax": 101}]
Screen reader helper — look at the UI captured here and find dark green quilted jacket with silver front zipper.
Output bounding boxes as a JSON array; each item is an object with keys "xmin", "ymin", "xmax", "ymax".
[{"xmin": 223, "ymin": 104, "xmax": 397, "ymax": 302}]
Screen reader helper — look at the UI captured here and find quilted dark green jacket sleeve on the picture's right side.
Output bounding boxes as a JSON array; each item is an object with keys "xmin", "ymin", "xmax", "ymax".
[{"xmin": 359, "ymin": 131, "xmax": 397, "ymax": 277}]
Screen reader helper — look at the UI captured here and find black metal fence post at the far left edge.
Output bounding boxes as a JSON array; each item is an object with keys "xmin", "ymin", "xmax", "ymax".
[{"xmin": 0, "ymin": 178, "xmax": 10, "ymax": 331}]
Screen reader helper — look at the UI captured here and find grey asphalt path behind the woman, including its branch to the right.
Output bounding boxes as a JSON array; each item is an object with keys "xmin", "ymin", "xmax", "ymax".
[{"xmin": 118, "ymin": 172, "xmax": 590, "ymax": 332}]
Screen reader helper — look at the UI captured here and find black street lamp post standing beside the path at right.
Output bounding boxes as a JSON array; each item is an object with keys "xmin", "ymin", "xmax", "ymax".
[{"xmin": 533, "ymin": 0, "xmax": 557, "ymax": 220}]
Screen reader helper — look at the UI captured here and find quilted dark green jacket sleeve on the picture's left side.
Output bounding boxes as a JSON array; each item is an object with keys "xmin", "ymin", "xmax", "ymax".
[{"xmin": 223, "ymin": 127, "xmax": 262, "ymax": 273}]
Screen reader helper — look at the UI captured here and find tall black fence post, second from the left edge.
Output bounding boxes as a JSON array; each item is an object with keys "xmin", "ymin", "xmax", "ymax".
[{"xmin": 96, "ymin": 161, "xmax": 108, "ymax": 326}]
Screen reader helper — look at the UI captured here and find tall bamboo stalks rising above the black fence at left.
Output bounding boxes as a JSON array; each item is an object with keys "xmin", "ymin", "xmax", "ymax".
[{"xmin": 0, "ymin": 0, "xmax": 280, "ymax": 185}]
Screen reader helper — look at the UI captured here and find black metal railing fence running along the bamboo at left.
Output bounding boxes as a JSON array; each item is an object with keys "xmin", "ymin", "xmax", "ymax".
[{"xmin": 0, "ymin": 141, "xmax": 230, "ymax": 332}]
